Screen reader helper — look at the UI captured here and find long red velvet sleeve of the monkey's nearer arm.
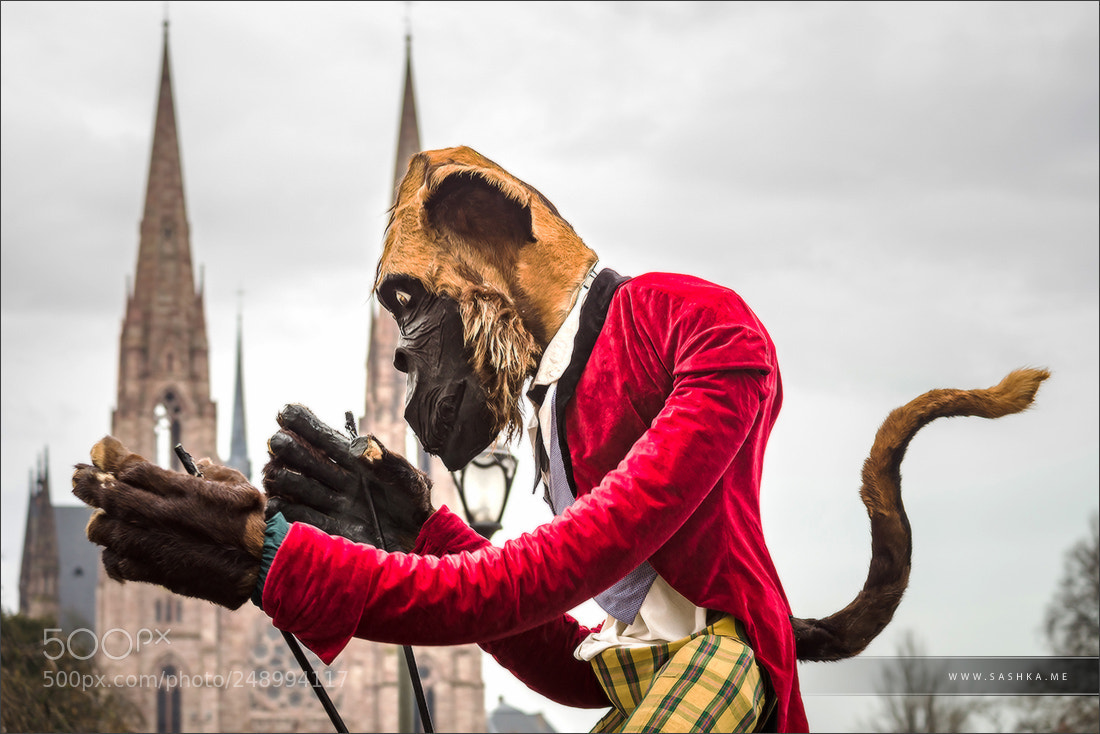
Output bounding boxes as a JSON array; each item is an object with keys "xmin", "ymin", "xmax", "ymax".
[{"xmin": 263, "ymin": 371, "xmax": 760, "ymax": 662}]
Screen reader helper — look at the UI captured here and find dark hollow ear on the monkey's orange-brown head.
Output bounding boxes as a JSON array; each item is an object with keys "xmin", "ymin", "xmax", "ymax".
[{"xmin": 424, "ymin": 168, "xmax": 535, "ymax": 248}]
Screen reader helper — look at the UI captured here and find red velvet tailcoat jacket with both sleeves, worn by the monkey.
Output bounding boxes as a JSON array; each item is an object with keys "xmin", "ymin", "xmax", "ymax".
[{"xmin": 263, "ymin": 274, "xmax": 807, "ymax": 731}]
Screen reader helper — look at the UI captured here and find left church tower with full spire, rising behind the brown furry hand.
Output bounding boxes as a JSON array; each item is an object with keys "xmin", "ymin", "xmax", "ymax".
[{"xmin": 96, "ymin": 21, "xmax": 235, "ymax": 732}]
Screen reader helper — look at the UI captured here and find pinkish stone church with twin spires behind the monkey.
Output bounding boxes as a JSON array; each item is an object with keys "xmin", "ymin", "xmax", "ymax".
[{"xmin": 20, "ymin": 23, "xmax": 486, "ymax": 732}]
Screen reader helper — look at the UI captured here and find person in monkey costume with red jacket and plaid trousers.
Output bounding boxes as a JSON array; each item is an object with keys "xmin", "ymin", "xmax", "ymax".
[{"xmin": 74, "ymin": 147, "xmax": 1045, "ymax": 732}]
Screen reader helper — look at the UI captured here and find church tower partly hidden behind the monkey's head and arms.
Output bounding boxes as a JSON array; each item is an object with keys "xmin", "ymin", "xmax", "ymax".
[{"xmin": 359, "ymin": 35, "xmax": 486, "ymax": 732}]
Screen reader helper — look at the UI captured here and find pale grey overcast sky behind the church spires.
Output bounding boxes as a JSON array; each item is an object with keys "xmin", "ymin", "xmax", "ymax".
[{"xmin": 0, "ymin": 2, "xmax": 1100, "ymax": 730}]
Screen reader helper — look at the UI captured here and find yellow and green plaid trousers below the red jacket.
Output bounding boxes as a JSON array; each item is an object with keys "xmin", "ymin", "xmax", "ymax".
[{"xmin": 592, "ymin": 616, "xmax": 770, "ymax": 732}]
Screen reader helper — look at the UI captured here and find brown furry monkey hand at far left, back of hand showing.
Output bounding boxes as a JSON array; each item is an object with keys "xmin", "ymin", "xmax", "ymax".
[{"xmin": 73, "ymin": 436, "xmax": 265, "ymax": 610}]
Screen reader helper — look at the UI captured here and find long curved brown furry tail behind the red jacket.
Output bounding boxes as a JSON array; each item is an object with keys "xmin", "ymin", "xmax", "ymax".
[{"xmin": 791, "ymin": 370, "xmax": 1051, "ymax": 660}]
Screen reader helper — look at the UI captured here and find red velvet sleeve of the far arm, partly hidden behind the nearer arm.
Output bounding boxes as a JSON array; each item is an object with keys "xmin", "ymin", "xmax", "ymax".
[{"xmin": 413, "ymin": 506, "xmax": 611, "ymax": 709}]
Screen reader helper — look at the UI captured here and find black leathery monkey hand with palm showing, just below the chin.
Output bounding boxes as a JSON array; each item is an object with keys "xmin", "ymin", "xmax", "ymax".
[{"xmin": 264, "ymin": 405, "xmax": 435, "ymax": 551}]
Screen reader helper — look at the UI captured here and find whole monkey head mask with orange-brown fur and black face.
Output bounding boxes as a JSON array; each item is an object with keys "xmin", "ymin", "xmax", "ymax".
[{"xmin": 374, "ymin": 147, "xmax": 596, "ymax": 468}]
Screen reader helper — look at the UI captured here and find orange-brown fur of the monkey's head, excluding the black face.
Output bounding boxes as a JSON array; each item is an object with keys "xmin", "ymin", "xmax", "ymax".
[{"xmin": 374, "ymin": 147, "xmax": 597, "ymax": 437}]
